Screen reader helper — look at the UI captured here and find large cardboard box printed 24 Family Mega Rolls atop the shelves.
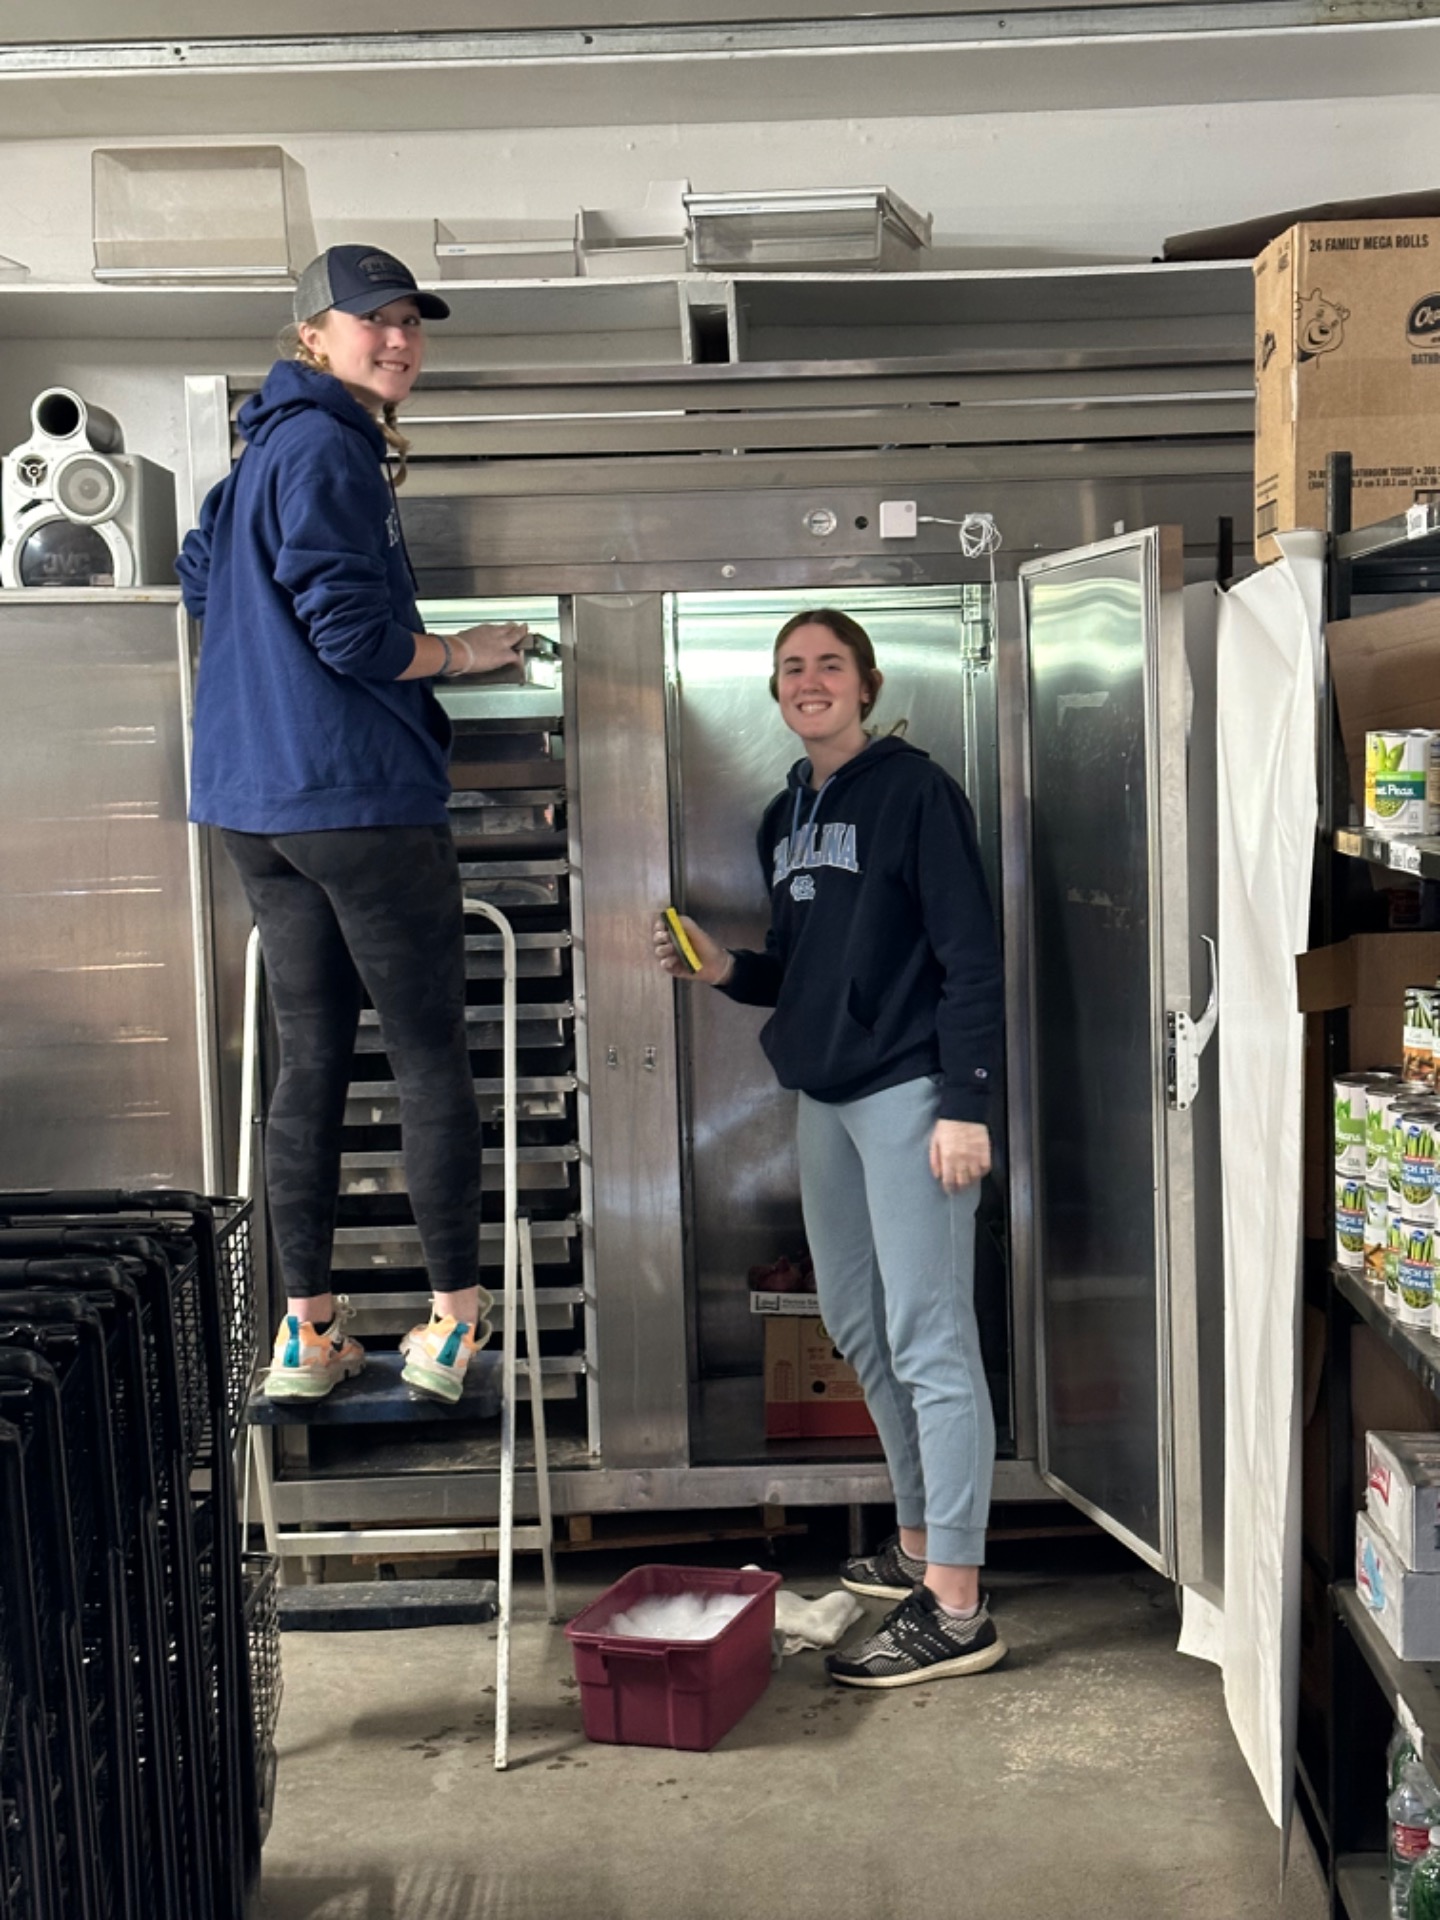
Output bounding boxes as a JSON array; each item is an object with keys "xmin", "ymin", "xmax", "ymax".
[{"xmin": 1256, "ymin": 219, "xmax": 1440, "ymax": 561}]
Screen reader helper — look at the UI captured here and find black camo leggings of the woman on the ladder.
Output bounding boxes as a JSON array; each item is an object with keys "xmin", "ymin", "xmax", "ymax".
[{"xmin": 221, "ymin": 828, "xmax": 480, "ymax": 1300}]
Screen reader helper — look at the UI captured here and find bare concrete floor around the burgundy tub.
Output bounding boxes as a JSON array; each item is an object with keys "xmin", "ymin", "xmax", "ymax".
[{"xmin": 263, "ymin": 1548, "xmax": 1325, "ymax": 1920}]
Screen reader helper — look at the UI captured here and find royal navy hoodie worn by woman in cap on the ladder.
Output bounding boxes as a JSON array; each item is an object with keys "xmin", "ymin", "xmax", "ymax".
[{"xmin": 177, "ymin": 361, "xmax": 451, "ymax": 833}]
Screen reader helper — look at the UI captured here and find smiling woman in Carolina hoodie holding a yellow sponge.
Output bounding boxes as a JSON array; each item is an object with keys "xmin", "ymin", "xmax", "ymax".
[{"xmin": 655, "ymin": 607, "xmax": 1006, "ymax": 1688}]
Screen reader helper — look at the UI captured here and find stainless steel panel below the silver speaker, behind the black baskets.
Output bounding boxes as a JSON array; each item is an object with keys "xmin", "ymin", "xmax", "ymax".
[{"xmin": 0, "ymin": 591, "xmax": 215, "ymax": 1188}]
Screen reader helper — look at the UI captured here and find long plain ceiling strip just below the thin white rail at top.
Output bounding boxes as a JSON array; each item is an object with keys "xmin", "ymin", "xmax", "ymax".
[{"xmin": 0, "ymin": 21, "xmax": 1440, "ymax": 140}]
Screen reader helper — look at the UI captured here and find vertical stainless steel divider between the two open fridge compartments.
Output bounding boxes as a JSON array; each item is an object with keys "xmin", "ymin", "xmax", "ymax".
[{"xmin": 572, "ymin": 593, "xmax": 689, "ymax": 1467}]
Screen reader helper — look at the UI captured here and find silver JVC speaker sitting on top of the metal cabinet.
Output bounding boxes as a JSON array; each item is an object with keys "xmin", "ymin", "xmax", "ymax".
[{"xmin": 0, "ymin": 386, "xmax": 177, "ymax": 588}]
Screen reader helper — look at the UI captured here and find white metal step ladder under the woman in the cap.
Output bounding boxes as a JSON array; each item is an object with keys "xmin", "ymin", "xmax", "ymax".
[{"xmin": 240, "ymin": 897, "xmax": 557, "ymax": 1770}]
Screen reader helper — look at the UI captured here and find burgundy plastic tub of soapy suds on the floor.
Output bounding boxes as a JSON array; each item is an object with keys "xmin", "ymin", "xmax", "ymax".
[{"xmin": 564, "ymin": 1567, "xmax": 780, "ymax": 1753}]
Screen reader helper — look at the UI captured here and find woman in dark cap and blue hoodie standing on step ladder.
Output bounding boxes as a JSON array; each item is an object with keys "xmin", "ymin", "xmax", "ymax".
[{"xmin": 177, "ymin": 246, "xmax": 526, "ymax": 1400}]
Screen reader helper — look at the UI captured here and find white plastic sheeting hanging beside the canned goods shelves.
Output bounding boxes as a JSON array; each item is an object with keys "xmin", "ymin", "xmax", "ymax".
[{"xmin": 1181, "ymin": 534, "xmax": 1325, "ymax": 1834}]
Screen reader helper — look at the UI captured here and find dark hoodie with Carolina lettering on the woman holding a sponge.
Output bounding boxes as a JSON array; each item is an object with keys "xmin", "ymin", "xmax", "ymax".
[{"xmin": 724, "ymin": 739, "xmax": 1004, "ymax": 1121}]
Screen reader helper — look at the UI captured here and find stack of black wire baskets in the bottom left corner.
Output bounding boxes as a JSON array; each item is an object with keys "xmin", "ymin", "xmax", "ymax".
[{"xmin": 0, "ymin": 1192, "xmax": 278, "ymax": 1920}]
